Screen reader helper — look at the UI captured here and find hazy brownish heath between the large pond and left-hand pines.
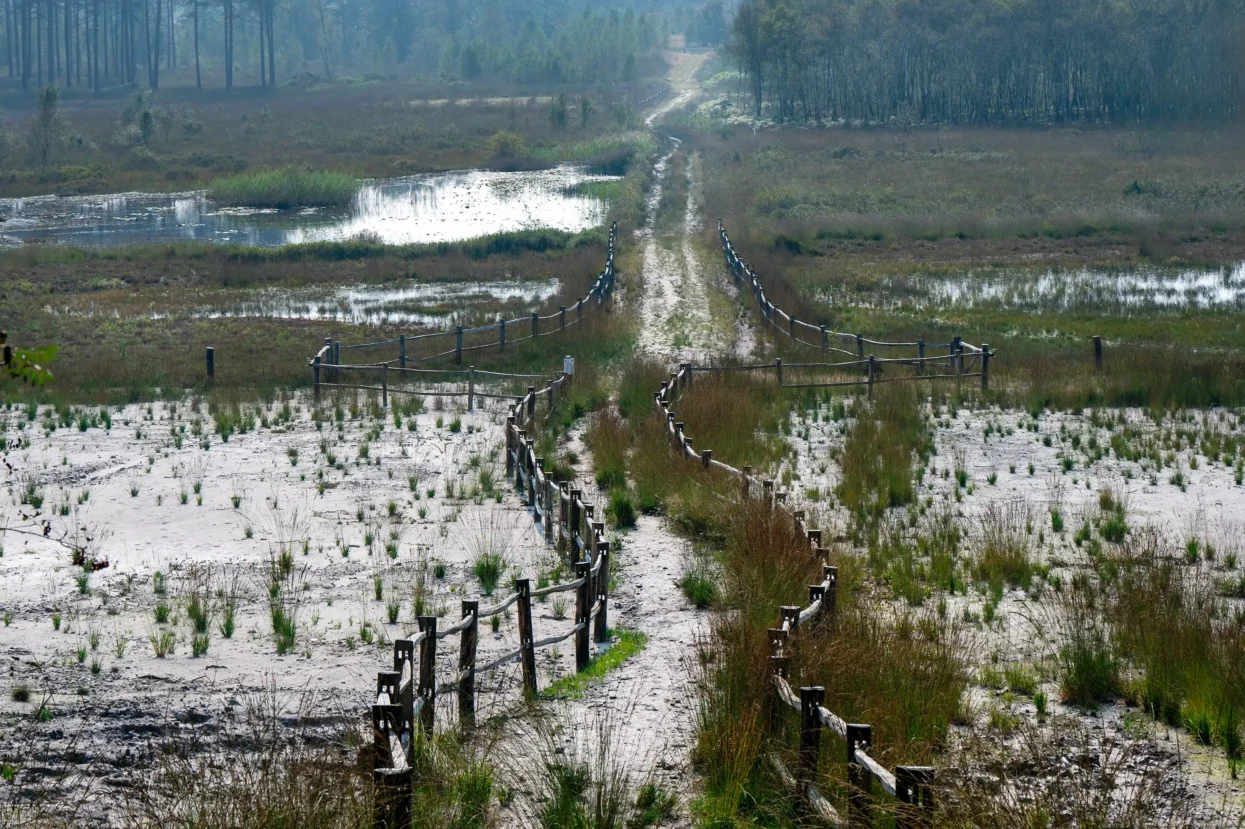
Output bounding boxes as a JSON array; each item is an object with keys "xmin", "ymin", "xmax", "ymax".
[{"xmin": 0, "ymin": 74, "xmax": 650, "ymax": 197}]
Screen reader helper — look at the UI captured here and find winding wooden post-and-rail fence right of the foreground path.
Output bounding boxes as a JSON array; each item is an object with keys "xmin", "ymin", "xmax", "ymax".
[{"xmin": 654, "ymin": 363, "xmax": 936, "ymax": 829}]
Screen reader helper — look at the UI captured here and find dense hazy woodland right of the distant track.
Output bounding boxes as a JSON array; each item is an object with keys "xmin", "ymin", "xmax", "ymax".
[{"xmin": 728, "ymin": 0, "xmax": 1245, "ymax": 123}]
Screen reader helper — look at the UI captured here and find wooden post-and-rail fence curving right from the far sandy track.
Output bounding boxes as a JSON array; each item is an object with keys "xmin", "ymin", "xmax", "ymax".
[{"xmin": 717, "ymin": 220, "xmax": 995, "ymax": 390}]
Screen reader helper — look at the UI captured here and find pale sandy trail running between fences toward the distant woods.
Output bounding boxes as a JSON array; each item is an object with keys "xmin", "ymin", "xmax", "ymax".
[{"xmin": 512, "ymin": 55, "xmax": 753, "ymax": 827}]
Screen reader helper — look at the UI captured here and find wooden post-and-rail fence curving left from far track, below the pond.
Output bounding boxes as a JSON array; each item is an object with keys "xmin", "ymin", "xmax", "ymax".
[{"xmin": 309, "ymin": 222, "xmax": 618, "ymax": 373}]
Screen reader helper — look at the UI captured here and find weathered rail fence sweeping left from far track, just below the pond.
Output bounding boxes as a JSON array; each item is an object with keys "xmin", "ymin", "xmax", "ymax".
[{"xmin": 309, "ymin": 223, "xmax": 618, "ymax": 390}]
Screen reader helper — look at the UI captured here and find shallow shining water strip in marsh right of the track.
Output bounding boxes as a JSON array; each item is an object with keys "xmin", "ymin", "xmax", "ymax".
[{"xmin": 823, "ymin": 263, "xmax": 1245, "ymax": 312}]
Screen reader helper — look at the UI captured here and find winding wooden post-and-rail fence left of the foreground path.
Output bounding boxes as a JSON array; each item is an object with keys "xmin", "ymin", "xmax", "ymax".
[{"xmin": 372, "ymin": 373, "xmax": 610, "ymax": 829}]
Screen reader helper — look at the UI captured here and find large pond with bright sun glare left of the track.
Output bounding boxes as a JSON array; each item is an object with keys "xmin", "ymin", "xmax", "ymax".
[{"xmin": 0, "ymin": 167, "xmax": 615, "ymax": 248}]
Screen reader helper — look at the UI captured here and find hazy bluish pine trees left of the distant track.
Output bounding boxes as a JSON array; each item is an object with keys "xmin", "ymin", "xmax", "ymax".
[{"xmin": 0, "ymin": 0, "xmax": 669, "ymax": 93}]
